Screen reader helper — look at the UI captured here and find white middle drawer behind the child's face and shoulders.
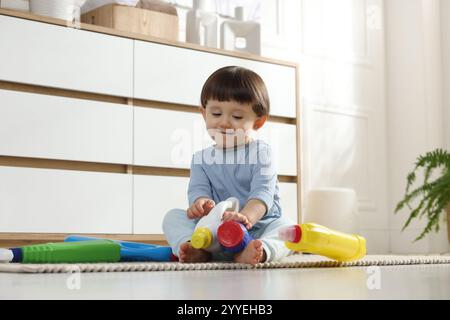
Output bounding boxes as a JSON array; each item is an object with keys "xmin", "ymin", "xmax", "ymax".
[{"xmin": 134, "ymin": 108, "xmax": 297, "ymax": 175}]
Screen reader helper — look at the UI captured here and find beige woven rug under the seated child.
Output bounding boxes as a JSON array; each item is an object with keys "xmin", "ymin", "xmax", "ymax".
[{"xmin": 0, "ymin": 254, "xmax": 450, "ymax": 273}]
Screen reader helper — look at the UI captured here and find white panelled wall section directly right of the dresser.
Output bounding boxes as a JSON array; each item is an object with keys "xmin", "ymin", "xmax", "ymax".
[{"xmin": 300, "ymin": 0, "xmax": 389, "ymax": 254}]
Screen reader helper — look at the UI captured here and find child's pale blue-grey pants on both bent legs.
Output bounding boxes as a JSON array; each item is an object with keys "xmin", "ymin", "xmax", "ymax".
[{"xmin": 162, "ymin": 209, "xmax": 295, "ymax": 262}]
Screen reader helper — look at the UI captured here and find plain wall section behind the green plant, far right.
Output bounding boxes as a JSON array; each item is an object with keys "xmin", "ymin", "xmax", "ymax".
[{"xmin": 385, "ymin": 0, "xmax": 449, "ymax": 253}]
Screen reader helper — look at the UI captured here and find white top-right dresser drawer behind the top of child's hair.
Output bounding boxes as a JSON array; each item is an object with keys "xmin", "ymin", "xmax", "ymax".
[{"xmin": 134, "ymin": 41, "xmax": 296, "ymax": 117}]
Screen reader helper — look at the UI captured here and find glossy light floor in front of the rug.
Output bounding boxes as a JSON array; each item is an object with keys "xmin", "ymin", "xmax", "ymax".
[{"xmin": 0, "ymin": 264, "xmax": 450, "ymax": 300}]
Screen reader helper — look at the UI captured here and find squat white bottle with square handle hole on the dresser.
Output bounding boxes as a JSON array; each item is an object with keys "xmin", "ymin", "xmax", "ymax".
[{"xmin": 220, "ymin": 7, "xmax": 261, "ymax": 55}]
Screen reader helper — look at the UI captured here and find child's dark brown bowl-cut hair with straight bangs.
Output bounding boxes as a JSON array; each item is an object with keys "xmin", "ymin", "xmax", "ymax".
[{"xmin": 200, "ymin": 66, "xmax": 270, "ymax": 117}]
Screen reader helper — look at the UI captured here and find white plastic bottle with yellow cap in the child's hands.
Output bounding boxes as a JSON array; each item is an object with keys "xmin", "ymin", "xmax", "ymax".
[{"xmin": 191, "ymin": 197, "xmax": 239, "ymax": 252}]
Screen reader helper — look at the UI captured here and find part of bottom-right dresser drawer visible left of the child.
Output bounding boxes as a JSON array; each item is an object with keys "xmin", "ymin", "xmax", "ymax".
[{"xmin": 134, "ymin": 175, "xmax": 189, "ymax": 234}]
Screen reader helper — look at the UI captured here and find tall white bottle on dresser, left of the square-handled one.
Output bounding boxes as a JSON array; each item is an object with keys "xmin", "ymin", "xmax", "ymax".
[{"xmin": 186, "ymin": 0, "xmax": 218, "ymax": 48}]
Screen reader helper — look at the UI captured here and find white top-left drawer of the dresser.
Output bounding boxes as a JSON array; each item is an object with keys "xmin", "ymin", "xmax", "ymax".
[{"xmin": 0, "ymin": 15, "xmax": 133, "ymax": 97}]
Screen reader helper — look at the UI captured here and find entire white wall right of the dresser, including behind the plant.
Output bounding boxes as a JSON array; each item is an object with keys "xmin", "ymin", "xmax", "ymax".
[{"xmin": 268, "ymin": 0, "xmax": 450, "ymax": 253}]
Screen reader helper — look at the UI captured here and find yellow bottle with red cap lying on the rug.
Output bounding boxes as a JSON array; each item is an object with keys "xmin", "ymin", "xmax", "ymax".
[{"xmin": 279, "ymin": 223, "xmax": 366, "ymax": 262}]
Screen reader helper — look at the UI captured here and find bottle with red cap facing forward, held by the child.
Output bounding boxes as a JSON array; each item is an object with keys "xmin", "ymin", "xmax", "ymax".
[{"xmin": 217, "ymin": 221, "xmax": 253, "ymax": 253}]
